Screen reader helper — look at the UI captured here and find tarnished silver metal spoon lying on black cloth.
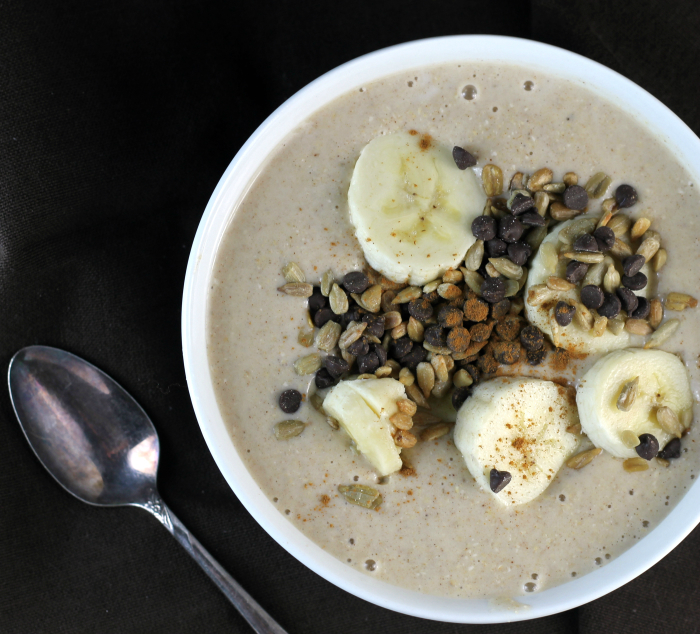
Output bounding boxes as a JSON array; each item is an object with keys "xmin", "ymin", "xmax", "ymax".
[{"xmin": 8, "ymin": 346, "xmax": 286, "ymax": 634}]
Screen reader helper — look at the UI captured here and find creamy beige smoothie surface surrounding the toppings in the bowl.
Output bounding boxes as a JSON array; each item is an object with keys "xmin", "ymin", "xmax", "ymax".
[{"xmin": 208, "ymin": 63, "xmax": 700, "ymax": 598}]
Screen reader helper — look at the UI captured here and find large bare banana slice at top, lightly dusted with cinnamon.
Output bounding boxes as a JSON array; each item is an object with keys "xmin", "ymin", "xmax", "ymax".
[{"xmin": 348, "ymin": 132, "xmax": 486, "ymax": 286}]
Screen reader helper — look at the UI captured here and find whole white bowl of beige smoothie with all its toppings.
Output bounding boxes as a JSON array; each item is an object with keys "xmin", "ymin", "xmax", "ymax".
[{"xmin": 183, "ymin": 36, "xmax": 700, "ymax": 623}]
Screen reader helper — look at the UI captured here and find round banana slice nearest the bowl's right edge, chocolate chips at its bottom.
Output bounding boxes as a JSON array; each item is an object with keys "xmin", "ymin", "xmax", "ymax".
[{"xmin": 576, "ymin": 348, "xmax": 693, "ymax": 458}]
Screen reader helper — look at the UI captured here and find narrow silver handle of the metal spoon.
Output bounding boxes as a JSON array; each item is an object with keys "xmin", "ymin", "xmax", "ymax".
[{"xmin": 142, "ymin": 494, "xmax": 287, "ymax": 634}]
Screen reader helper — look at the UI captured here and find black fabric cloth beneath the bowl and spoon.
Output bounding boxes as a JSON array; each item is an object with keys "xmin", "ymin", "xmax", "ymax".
[{"xmin": 0, "ymin": 0, "xmax": 700, "ymax": 634}]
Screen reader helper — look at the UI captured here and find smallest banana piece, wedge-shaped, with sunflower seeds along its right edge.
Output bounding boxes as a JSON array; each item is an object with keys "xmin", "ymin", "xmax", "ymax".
[{"xmin": 323, "ymin": 379, "xmax": 406, "ymax": 476}]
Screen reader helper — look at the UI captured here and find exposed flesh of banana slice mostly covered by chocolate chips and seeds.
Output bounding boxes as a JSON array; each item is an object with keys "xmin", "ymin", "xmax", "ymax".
[{"xmin": 523, "ymin": 216, "xmax": 653, "ymax": 354}]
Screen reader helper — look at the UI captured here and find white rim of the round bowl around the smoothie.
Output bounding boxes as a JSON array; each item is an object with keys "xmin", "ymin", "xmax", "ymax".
[{"xmin": 182, "ymin": 36, "xmax": 700, "ymax": 623}]
